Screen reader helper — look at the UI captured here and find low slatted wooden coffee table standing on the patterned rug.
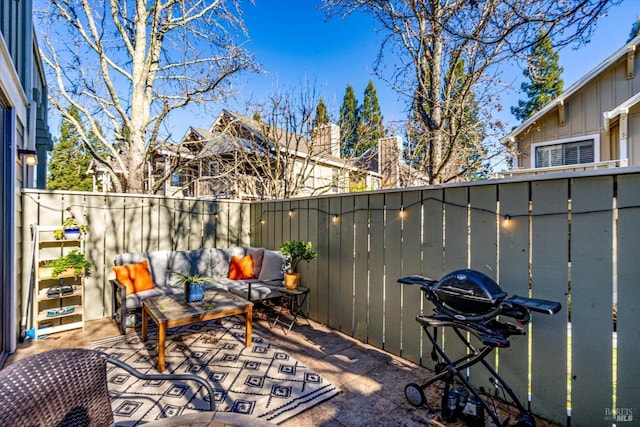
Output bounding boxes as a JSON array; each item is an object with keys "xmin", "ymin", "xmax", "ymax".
[{"xmin": 142, "ymin": 289, "xmax": 253, "ymax": 372}]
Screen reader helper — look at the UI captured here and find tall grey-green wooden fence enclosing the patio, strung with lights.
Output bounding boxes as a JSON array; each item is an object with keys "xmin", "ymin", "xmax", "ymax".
[{"xmin": 18, "ymin": 168, "xmax": 640, "ymax": 425}]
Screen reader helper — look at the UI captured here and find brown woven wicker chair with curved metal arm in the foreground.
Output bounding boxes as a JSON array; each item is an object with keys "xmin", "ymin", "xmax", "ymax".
[{"xmin": 0, "ymin": 349, "xmax": 215, "ymax": 427}]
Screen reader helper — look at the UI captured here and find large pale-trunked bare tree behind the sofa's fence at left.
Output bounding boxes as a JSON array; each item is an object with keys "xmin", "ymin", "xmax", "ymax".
[{"xmin": 39, "ymin": 0, "xmax": 257, "ymax": 193}]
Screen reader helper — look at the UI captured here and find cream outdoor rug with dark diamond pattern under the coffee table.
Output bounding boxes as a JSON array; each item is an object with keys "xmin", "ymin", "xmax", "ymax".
[{"xmin": 92, "ymin": 318, "xmax": 340, "ymax": 426}]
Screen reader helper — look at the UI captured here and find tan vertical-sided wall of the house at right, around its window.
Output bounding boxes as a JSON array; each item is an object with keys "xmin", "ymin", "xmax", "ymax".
[{"xmin": 517, "ymin": 44, "xmax": 640, "ymax": 169}]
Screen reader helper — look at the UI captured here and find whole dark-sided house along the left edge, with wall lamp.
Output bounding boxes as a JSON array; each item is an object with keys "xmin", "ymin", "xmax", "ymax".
[{"xmin": 0, "ymin": 0, "xmax": 52, "ymax": 360}]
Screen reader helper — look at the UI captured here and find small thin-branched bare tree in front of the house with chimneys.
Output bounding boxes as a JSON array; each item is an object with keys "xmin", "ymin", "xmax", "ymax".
[{"xmin": 212, "ymin": 85, "xmax": 347, "ymax": 198}]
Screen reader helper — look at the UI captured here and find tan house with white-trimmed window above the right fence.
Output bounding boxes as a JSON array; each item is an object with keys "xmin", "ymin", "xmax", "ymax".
[{"xmin": 502, "ymin": 37, "xmax": 640, "ymax": 176}]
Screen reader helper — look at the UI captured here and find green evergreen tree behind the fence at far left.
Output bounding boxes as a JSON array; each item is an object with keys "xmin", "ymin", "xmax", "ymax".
[{"xmin": 47, "ymin": 107, "xmax": 93, "ymax": 191}]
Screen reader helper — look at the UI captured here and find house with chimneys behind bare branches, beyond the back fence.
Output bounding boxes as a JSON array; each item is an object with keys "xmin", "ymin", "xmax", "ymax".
[{"xmin": 144, "ymin": 110, "xmax": 426, "ymax": 200}]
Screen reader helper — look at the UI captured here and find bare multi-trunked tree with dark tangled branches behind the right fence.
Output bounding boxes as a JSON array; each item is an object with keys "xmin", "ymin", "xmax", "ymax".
[{"xmin": 324, "ymin": 0, "xmax": 616, "ymax": 184}]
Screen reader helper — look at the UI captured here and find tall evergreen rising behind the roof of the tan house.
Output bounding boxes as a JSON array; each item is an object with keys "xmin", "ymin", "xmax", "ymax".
[{"xmin": 511, "ymin": 32, "xmax": 564, "ymax": 122}]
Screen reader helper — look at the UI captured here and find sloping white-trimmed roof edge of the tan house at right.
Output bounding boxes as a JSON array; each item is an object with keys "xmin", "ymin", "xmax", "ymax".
[{"xmin": 501, "ymin": 36, "xmax": 640, "ymax": 144}]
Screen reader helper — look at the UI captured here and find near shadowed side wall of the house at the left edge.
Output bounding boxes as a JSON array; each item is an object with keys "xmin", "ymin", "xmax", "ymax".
[{"xmin": 0, "ymin": 0, "xmax": 36, "ymax": 362}]
